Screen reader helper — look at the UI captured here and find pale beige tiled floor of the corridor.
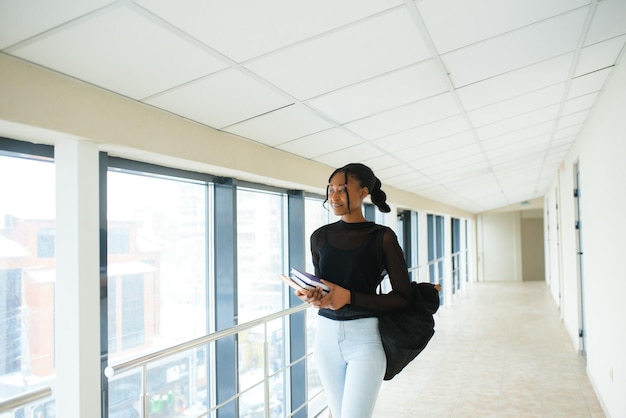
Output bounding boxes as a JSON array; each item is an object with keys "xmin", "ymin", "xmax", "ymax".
[{"xmin": 374, "ymin": 282, "xmax": 604, "ymax": 418}]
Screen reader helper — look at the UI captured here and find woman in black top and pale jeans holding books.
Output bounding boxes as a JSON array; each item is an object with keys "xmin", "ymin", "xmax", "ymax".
[{"xmin": 296, "ymin": 163, "xmax": 410, "ymax": 418}]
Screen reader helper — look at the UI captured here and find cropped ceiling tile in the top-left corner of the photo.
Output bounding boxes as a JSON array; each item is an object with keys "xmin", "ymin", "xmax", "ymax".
[{"xmin": 0, "ymin": 0, "xmax": 115, "ymax": 49}]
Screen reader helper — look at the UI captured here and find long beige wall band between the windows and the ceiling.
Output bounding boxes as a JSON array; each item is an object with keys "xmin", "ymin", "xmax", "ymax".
[{"xmin": 0, "ymin": 53, "xmax": 474, "ymax": 218}]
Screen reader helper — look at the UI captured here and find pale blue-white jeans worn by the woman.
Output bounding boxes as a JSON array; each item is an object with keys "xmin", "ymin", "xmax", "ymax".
[{"xmin": 313, "ymin": 316, "xmax": 387, "ymax": 418}]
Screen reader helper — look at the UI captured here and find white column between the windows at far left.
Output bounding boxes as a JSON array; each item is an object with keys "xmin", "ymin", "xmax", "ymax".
[{"xmin": 54, "ymin": 139, "xmax": 101, "ymax": 418}]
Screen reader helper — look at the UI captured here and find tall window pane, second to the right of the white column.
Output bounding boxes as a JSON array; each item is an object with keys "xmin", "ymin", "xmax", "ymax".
[{"xmin": 237, "ymin": 188, "xmax": 287, "ymax": 417}]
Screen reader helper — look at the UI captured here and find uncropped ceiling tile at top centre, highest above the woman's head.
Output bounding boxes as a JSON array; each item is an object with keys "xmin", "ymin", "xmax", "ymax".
[{"xmin": 245, "ymin": 8, "xmax": 430, "ymax": 100}]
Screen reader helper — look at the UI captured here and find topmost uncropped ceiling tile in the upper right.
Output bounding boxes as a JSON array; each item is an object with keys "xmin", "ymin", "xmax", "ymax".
[{"xmin": 441, "ymin": 8, "xmax": 587, "ymax": 87}]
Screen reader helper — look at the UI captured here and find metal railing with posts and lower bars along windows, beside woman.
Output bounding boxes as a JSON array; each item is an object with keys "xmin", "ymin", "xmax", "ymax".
[{"xmin": 104, "ymin": 304, "xmax": 317, "ymax": 418}]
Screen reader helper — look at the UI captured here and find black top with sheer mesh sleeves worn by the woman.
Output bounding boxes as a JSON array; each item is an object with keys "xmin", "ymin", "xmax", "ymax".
[{"xmin": 311, "ymin": 221, "xmax": 411, "ymax": 320}]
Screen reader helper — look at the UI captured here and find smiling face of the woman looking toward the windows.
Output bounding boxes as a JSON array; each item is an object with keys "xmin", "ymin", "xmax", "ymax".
[{"xmin": 327, "ymin": 172, "xmax": 369, "ymax": 222}]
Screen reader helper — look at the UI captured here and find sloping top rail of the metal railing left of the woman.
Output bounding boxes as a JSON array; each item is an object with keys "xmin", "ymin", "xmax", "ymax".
[{"xmin": 104, "ymin": 303, "xmax": 310, "ymax": 379}]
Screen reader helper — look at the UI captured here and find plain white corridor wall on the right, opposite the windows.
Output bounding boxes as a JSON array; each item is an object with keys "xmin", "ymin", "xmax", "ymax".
[{"xmin": 546, "ymin": 55, "xmax": 626, "ymax": 417}]
